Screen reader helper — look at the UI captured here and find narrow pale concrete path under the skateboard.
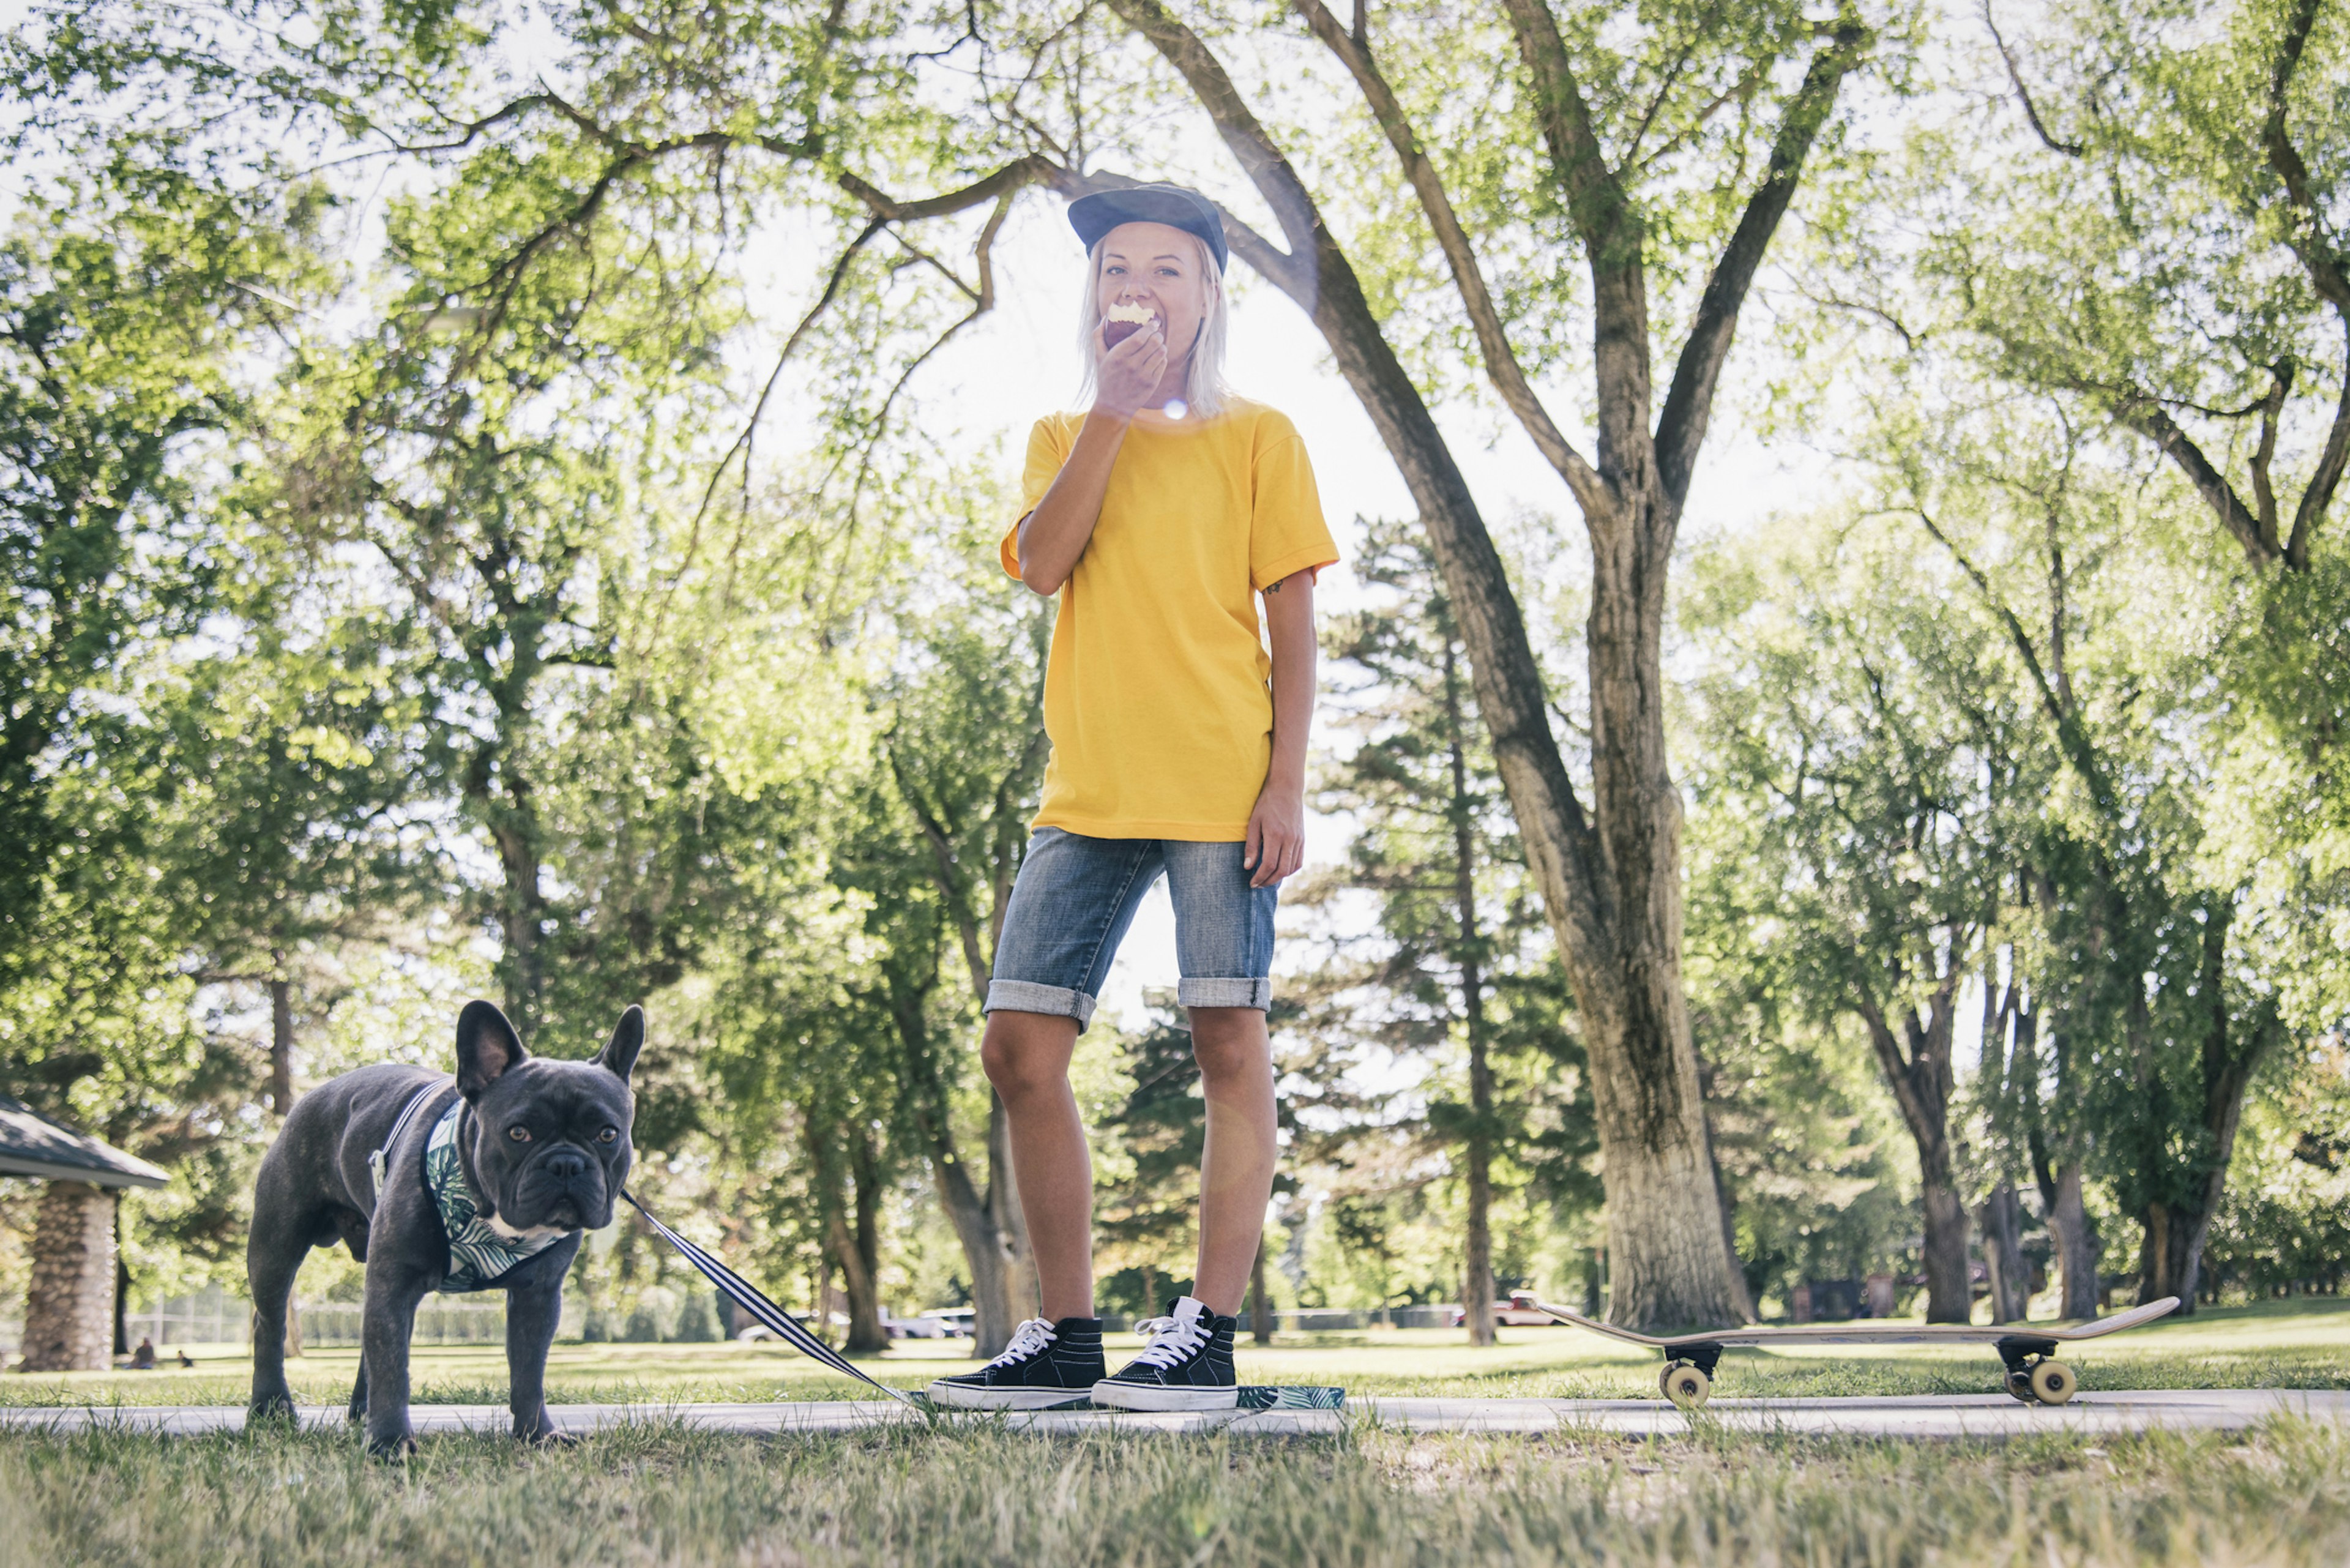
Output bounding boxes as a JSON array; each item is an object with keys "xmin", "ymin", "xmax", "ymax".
[{"xmin": 0, "ymin": 1389, "xmax": 2350, "ymax": 1439}]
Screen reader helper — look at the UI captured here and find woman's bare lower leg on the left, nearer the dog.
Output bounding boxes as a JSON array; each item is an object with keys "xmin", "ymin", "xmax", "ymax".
[{"xmin": 980, "ymin": 1011, "xmax": 1100, "ymax": 1324}]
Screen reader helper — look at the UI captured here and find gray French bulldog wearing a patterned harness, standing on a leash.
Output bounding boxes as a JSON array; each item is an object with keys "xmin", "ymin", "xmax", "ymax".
[{"xmin": 244, "ymin": 1001, "xmax": 644, "ymax": 1455}]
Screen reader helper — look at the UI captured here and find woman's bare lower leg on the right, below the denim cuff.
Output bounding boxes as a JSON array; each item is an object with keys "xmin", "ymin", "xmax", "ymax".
[{"xmin": 1184, "ymin": 1006, "xmax": 1278, "ymax": 1316}]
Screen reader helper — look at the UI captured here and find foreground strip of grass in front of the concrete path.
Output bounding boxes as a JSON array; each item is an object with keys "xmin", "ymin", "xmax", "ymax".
[{"xmin": 0, "ymin": 1422, "xmax": 2350, "ymax": 1568}]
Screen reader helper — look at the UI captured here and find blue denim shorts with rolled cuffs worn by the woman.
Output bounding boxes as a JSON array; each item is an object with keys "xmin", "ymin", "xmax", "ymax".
[{"xmin": 987, "ymin": 827, "xmax": 1278, "ymax": 1029}]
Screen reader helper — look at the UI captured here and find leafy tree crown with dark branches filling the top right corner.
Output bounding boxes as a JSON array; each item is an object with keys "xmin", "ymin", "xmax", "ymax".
[{"xmin": 1903, "ymin": 0, "xmax": 2350, "ymax": 573}]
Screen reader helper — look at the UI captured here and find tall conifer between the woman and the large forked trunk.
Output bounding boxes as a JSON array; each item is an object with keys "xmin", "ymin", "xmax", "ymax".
[{"xmin": 1283, "ymin": 522, "xmax": 1598, "ymax": 1300}]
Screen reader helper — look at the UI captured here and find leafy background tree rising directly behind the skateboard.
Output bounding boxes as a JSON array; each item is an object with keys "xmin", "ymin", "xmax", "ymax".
[{"xmin": 1692, "ymin": 510, "xmax": 2047, "ymax": 1324}]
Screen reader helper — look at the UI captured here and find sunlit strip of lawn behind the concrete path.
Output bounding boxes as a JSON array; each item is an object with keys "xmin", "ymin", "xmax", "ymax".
[{"xmin": 0, "ymin": 1297, "xmax": 2350, "ymax": 1406}]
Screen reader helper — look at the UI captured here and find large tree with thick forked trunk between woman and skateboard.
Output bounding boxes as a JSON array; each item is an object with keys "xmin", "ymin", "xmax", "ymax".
[{"xmin": 1029, "ymin": 0, "xmax": 1871, "ymax": 1326}]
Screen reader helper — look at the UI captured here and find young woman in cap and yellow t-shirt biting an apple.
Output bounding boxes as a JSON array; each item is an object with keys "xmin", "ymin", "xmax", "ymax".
[{"xmin": 931, "ymin": 185, "xmax": 1337, "ymax": 1411}]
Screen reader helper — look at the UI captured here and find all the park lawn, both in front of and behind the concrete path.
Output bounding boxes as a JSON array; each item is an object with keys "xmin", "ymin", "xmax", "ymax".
[{"xmin": 0, "ymin": 1302, "xmax": 2350, "ymax": 1568}]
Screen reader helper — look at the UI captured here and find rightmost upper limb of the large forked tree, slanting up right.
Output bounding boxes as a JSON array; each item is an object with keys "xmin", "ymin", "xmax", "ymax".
[{"xmin": 1654, "ymin": 13, "xmax": 1868, "ymax": 515}]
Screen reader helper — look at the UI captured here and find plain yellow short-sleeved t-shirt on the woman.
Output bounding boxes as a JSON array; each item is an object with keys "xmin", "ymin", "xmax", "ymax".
[{"xmin": 1004, "ymin": 400, "xmax": 1337, "ymax": 842}]
